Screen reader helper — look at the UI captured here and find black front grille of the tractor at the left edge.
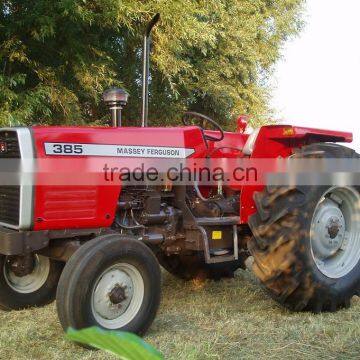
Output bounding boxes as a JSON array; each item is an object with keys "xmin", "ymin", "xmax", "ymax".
[{"xmin": 0, "ymin": 130, "xmax": 21, "ymax": 226}]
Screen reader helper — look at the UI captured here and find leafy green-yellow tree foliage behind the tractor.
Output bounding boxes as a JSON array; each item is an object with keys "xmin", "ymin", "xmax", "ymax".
[{"xmin": 0, "ymin": 0, "xmax": 303, "ymax": 125}]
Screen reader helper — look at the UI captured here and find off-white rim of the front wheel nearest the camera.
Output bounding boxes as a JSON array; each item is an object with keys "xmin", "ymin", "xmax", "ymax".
[{"xmin": 91, "ymin": 263, "xmax": 144, "ymax": 329}]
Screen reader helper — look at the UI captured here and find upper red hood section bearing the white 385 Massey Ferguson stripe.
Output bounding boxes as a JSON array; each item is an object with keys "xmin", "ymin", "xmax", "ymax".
[{"xmin": 32, "ymin": 126, "xmax": 206, "ymax": 159}]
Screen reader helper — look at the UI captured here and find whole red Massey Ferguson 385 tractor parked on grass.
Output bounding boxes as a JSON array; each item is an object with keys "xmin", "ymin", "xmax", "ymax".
[{"xmin": 0, "ymin": 14, "xmax": 360, "ymax": 334}]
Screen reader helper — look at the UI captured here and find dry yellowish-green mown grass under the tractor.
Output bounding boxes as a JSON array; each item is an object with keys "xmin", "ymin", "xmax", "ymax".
[{"xmin": 0, "ymin": 271, "xmax": 360, "ymax": 360}]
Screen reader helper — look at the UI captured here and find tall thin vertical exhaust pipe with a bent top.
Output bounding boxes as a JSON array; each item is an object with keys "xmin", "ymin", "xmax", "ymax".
[{"xmin": 141, "ymin": 13, "xmax": 160, "ymax": 127}]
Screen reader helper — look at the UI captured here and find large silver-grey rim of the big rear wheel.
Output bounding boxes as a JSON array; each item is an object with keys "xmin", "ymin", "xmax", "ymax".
[{"xmin": 310, "ymin": 187, "xmax": 360, "ymax": 279}]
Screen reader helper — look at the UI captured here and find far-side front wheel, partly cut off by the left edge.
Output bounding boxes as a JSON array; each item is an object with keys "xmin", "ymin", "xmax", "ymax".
[{"xmin": 0, "ymin": 254, "xmax": 63, "ymax": 310}]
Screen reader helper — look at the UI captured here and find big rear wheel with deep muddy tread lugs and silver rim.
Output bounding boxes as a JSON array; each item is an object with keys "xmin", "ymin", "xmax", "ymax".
[{"xmin": 249, "ymin": 144, "xmax": 360, "ymax": 312}]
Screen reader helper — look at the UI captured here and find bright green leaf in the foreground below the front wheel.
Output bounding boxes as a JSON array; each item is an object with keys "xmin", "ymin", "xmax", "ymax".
[{"xmin": 66, "ymin": 326, "xmax": 164, "ymax": 360}]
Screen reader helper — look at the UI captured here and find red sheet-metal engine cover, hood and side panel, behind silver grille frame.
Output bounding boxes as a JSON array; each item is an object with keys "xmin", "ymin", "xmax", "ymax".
[{"xmin": 33, "ymin": 127, "xmax": 206, "ymax": 230}]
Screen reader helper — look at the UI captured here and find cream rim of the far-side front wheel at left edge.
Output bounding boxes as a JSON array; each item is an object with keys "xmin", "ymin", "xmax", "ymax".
[{"xmin": 3, "ymin": 255, "xmax": 50, "ymax": 294}]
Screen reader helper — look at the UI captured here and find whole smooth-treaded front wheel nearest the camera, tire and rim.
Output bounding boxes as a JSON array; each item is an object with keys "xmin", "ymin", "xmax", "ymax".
[{"xmin": 56, "ymin": 235, "xmax": 161, "ymax": 335}]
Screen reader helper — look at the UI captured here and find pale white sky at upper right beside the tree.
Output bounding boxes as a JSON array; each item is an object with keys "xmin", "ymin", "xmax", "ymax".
[{"xmin": 272, "ymin": 0, "xmax": 360, "ymax": 152}]
